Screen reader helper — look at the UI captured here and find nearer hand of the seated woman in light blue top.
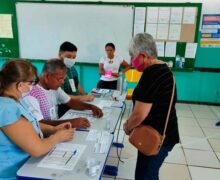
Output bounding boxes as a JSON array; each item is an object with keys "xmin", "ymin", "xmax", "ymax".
[{"xmin": 54, "ymin": 128, "xmax": 75, "ymax": 142}]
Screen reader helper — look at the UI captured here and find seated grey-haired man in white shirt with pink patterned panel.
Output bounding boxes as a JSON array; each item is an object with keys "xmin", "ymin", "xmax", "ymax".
[{"xmin": 23, "ymin": 59, "xmax": 103, "ymax": 128}]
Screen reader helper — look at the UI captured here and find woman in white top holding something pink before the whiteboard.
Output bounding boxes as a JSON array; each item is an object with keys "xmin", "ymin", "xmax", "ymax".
[{"xmin": 97, "ymin": 43, "xmax": 130, "ymax": 90}]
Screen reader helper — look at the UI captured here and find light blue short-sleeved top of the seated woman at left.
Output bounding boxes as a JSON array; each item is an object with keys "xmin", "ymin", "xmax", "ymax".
[{"xmin": 0, "ymin": 97, "xmax": 40, "ymax": 179}]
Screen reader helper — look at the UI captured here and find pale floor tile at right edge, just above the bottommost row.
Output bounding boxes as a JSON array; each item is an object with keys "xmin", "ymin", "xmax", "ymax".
[{"xmin": 184, "ymin": 149, "xmax": 220, "ymax": 168}]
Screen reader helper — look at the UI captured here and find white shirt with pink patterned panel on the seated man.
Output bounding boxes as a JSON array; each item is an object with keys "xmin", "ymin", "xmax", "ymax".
[{"xmin": 23, "ymin": 85, "xmax": 70, "ymax": 120}]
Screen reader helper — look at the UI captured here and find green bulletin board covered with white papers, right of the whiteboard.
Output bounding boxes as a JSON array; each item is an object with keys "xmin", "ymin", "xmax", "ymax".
[{"xmin": 133, "ymin": 3, "xmax": 202, "ymax": 71}]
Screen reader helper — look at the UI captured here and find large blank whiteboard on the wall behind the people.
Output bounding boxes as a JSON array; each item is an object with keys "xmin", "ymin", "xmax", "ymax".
[{"xmin": 16, "ymin": 2, "xmax": 133, "ymax": 63}]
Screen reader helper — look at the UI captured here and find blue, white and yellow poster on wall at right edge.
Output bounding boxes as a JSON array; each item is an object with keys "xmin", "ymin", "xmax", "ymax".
[{"xmin": 200, "ymin": 14, "xmax": 220, "ymax": 48}]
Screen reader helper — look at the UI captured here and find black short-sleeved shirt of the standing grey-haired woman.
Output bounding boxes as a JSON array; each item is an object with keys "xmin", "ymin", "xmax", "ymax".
[{"xmin": 132, "ymin": 64, "xmax": 179, "ymax": 145}]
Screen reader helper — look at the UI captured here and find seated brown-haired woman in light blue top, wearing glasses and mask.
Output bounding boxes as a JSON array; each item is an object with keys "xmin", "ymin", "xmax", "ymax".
[{"xmin": 0, "ymin": 60, "xmax": 73, "ymax": 179}]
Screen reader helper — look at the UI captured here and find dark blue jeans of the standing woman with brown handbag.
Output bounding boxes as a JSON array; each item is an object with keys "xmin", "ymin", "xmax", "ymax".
[{"xmin": 135, "ymin": 146, "xmax": 174, "ymax": 180}]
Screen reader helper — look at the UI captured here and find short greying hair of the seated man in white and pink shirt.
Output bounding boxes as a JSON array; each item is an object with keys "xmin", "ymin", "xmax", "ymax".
[{"xmin": 42, "ymin": 59, "xmax": 66, "ymax": 73}]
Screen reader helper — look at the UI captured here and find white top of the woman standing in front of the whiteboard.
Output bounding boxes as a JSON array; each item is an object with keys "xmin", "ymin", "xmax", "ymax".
[{"xmin": 99, "ymin": 56, "xmax": 123, "ymax": 81}]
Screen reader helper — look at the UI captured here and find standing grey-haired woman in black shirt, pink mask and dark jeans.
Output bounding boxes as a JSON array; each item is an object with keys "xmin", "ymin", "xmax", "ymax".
[{"xmin": 124, "ymin": 33, "xmax": 179, "ymax": 180}]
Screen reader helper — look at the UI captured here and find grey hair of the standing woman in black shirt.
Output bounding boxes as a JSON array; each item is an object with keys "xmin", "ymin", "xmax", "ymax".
[{"xmin": 129, "ymin": 33, "xmax": 157, "ymax": 58}]
